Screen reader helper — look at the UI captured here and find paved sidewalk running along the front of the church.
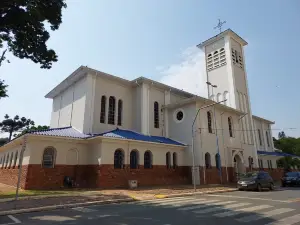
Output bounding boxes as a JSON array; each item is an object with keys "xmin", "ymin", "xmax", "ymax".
[{"xmin": 0, "ymin": 185, "xmax": 236, "ymax": 215}]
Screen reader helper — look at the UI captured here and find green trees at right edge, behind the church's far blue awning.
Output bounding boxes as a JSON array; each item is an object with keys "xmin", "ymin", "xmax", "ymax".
[{"xmin": 273, "ymin": 134, "xmax": 300, "ymax": 170}]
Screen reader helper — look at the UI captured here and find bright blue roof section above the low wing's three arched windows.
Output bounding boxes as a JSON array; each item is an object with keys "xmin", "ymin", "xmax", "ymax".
[{"xmin": 94, "ymin": 128, "xmax": 186, "ymax": 146}]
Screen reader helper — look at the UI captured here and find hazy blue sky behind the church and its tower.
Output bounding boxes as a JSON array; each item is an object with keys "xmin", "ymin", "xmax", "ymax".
[{"xmin": 0, "ymin": 0, "xmax": 300, "ymax": 136}]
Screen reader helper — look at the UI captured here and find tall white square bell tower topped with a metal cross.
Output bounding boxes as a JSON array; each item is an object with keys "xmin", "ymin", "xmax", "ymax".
[{"xmin": 197, "ymin": 27, "xmax": 257, "ymax": 166}]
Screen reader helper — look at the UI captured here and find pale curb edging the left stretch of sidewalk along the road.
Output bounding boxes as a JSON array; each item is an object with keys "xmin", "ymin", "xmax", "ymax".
[{"xmin": 0, "ymin": 198, "xmax": 135, "ymax": 216}]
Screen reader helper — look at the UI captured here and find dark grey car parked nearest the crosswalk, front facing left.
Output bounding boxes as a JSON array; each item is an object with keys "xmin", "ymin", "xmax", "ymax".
[{"xmin": 237, "ymin": 171, "xmax": 274, "ymax": 191}]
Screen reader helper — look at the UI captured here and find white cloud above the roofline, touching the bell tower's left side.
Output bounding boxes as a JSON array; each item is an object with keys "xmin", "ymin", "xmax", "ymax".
[{"xmin": 157, "ymin": 47, "xmax": 207, "ymax": 97}]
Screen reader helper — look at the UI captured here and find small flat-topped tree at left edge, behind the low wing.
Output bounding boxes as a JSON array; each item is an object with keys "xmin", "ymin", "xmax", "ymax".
[{"xmin": 0, "ymin": 114, "xmax": 34, "ymax": 141}]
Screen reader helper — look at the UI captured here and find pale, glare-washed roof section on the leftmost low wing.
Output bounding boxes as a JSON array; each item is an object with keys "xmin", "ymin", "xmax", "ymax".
[{"xmin": 29, "ymin": 127, "xmax": 91, "ymax": 139}]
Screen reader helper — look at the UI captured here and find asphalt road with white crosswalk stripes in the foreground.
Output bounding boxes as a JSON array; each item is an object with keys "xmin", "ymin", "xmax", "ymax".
[{"xmin": 0, "ymin": 188, "xmax": 300, "ymax": 225}]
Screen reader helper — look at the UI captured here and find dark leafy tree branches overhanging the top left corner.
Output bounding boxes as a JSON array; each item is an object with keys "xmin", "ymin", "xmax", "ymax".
[{"xmin": 0, "ymin": 0, "xmax": 67, "ymax": 69}]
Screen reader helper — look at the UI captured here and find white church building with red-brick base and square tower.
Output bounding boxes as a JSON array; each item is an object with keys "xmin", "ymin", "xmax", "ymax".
[{"xmin": 0, "ymin": 29, "xmax": 290, "ymax": 189}]
